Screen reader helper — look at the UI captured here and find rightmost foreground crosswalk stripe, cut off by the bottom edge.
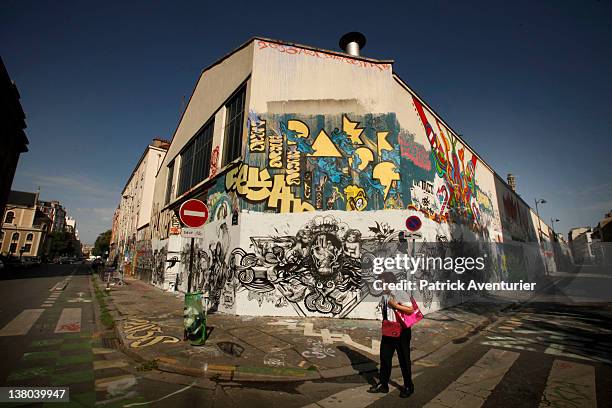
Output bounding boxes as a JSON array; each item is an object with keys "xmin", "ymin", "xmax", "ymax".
[{"xmin": 540, "ymin": 360, "xmax": 597, "ymax": 408}]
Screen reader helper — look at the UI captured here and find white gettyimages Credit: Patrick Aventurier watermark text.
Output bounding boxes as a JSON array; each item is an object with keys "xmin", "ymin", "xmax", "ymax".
[{"xmin": 372, "ymin": 254, "xmax": 536, "ymax": 291}]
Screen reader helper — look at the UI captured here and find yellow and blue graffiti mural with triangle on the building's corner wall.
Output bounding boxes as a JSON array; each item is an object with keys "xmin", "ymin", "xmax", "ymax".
[{"xmin": 239, "ymin": 112, "xmax": 408, "ymax": 213}]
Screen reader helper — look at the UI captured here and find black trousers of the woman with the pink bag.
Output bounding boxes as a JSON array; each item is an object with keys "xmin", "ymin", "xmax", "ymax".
[{"xmin": 380, "ymin": 328, "xmax": 414, "ymax": 388}]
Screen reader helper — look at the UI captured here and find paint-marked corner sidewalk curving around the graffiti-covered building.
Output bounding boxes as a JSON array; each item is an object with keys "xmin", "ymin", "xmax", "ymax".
[{"xmin": 101, "ymin": 279, "xmax": 512, "ymax": 381}]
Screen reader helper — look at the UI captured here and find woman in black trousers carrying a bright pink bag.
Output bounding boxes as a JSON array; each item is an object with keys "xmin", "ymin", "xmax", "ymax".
[{"xmin": 368, "ymin": 272, "xmax": 414, "ymax": 398}]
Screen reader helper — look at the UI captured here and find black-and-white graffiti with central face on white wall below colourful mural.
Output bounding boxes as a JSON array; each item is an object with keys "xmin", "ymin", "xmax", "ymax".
[{"xmin": 231, "ymin": 216, "xmax": 404, "ymax": 317}]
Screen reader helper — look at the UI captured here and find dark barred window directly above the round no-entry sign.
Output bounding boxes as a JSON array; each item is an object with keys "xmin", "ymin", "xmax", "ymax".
[{"xmin": 177, "ymin": 120, "xmax": 215, "ymax": 195}]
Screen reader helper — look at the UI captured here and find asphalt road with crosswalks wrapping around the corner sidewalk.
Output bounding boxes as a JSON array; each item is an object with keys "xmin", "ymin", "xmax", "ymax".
[{"xmin": 0, "ymin": 265, "xmax": 612, "ymax": 408}]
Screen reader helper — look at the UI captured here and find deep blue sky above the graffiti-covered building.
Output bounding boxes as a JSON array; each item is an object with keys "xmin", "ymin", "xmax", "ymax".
[{"xmin": 0, "ymin": 0, "xmax": 612, "ymax": 243}]
